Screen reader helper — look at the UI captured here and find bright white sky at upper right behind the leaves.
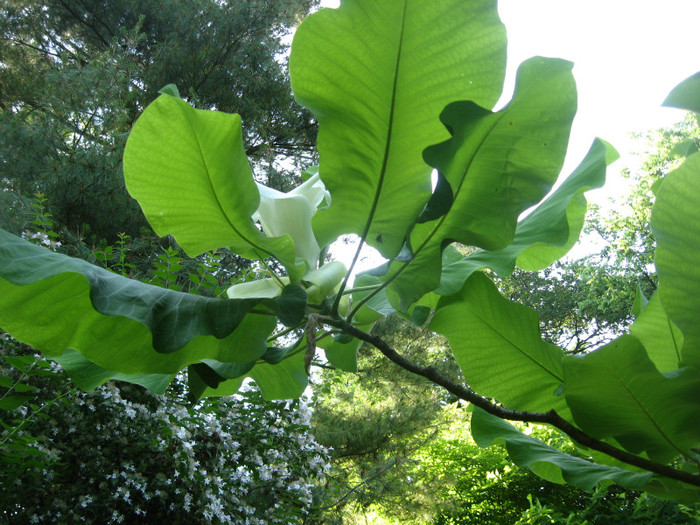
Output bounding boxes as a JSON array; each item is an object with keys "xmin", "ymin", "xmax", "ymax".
[{"xmin": 321, "ymin": 0, "xmax": 700, "ymax": 202}]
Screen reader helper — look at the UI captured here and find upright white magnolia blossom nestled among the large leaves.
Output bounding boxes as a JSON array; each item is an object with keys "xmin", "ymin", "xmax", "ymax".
[{"xmin": 252, "ymin": 173, "xmax": 331, "ymax": 268}]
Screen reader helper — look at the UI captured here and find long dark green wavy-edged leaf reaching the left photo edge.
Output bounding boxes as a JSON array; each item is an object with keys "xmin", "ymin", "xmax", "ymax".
[{"xmin": 0, "ymin": 230, "xmax": 275, "ymax": 375}]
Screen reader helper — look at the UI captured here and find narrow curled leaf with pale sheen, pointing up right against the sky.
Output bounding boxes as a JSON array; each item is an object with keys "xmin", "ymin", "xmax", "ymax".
[{"xmin": 436, "ymin": 139, "xmax": 618, "ymax": 295}]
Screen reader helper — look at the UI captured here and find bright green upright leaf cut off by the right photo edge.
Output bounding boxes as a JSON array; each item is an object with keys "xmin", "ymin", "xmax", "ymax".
[{"xmin": 651, "ymin": 153, "xmax": 700, "ymax": 367}]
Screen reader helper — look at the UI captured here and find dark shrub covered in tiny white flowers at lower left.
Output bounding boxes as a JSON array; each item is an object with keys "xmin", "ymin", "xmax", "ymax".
[{"xmin": 0, "ymin": 345, "xmax": 329, "ymax": 524}]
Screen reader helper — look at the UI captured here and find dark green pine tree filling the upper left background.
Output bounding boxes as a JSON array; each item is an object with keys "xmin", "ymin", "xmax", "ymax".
[{"xmin": 0, "ymin": 0, "xmax": 316, "ymax": 238}]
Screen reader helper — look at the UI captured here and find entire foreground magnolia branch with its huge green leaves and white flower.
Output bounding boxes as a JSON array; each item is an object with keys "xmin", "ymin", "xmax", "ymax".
[{"xmin": 0, "ymin": 0, "xmax": 700, "ymax": 501}]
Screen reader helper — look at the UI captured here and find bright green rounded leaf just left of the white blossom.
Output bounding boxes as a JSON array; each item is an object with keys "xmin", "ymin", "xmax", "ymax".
[{"xmin": 124, "ymin": 95, "xmax": 305, "ymax": 281}]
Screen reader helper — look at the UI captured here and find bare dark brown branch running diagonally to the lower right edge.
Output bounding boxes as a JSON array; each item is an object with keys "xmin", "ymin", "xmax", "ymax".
[{"xmin": 321, "ymin": 317, "xmax": 700, "ymax": 487}]
